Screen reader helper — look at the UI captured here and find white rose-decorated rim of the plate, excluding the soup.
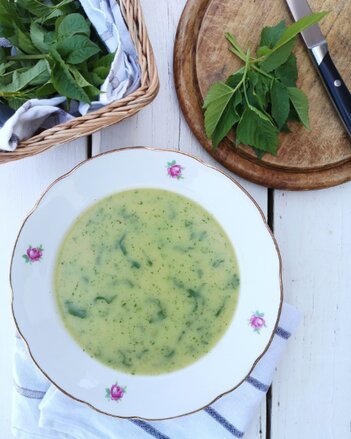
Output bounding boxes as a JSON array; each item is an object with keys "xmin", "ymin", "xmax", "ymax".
[{"xmin": 11, "ymin": 148, "xmax": 282, "ymax": 420}]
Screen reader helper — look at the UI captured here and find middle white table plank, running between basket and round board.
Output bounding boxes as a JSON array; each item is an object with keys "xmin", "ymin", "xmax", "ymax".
[{"xmin": 101, "ymin": 0, "xmax": 267, "ymax": 439}]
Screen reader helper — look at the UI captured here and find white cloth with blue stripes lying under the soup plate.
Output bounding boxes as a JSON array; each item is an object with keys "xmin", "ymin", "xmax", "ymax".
[{"xmin": 12, "ymin": 304, "xmax": 299, "ymax": 439}]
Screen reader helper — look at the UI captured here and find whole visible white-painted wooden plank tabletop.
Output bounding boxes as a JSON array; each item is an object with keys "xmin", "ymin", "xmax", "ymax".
[{"xmin": 0, "ymin": 0, "xmax": 351, "ymax": 439}]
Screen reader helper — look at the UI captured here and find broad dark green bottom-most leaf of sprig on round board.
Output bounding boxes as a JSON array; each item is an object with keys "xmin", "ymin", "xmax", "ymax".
[{"xmin": 236, "ymin": 108, "xmax": 279, "ymax": 155}]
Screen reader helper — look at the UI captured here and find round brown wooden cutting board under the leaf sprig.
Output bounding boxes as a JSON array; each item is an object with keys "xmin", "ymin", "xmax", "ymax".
[{"xmin": 174, "ymin": 0, "xmax": 351, "ymax": 190}]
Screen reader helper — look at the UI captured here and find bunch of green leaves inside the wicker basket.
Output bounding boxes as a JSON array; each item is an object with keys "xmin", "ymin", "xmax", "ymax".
[{"xmin": 0, "ymin": 0, "xmax": 114, "ymax": 109}]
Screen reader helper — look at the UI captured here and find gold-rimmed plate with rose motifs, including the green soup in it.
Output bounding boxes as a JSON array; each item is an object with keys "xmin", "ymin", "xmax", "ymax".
[{"xmin": 10, "ymin": 147, "xmax": 283, "ymax": 420}]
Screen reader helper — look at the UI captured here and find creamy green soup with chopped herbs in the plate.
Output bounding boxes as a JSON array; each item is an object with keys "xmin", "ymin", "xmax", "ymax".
[{"xmin": 55, "ymin": 189, "xmax": 239, "ymax": 375}]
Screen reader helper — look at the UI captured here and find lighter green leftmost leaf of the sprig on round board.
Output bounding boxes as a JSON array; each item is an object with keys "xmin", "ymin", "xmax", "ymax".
[{"xmin": 203, "ymin": 82, "xmax": 234, "ymax": 138}]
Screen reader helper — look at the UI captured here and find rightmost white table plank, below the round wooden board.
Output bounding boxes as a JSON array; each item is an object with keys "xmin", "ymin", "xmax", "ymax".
[{"xmin": 271, "ymin": 187, "xmax": 351, "ymax": 439}]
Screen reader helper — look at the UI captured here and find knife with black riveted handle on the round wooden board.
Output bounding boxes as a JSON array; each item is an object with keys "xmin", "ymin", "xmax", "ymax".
[{"xmin": 286, "ymin": 0, "xmax": 351, "ymax": 136}]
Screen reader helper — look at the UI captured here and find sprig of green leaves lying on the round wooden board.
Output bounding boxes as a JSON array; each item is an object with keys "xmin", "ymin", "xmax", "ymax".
[{"xmin": 203, "ymin": 12, "xmax": 327, "ymax": 158}]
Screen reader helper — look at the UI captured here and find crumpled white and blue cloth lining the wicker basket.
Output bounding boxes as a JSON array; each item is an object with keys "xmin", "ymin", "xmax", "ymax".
[{"xmin": 0, "ymin": 0, "xmax": 140, "ymax": 151}]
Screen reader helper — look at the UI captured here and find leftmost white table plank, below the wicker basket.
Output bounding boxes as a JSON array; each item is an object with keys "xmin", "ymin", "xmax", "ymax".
[{"xmin": 0, "ymin": 138, "xmax": 87, "ymax": 439}]
